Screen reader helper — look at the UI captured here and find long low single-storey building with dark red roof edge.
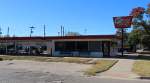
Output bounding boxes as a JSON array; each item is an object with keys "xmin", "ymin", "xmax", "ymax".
[{"xmin": 0, "ymin": 35, "xmax": 117, "ymax": 57}]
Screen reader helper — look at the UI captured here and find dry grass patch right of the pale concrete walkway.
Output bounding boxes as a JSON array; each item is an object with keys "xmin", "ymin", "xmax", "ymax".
[{"xmin": 132, "ymin": 60, "xmax": 150, "ymax": 77}]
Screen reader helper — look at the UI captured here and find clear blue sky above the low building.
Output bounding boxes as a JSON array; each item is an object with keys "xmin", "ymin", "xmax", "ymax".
[{"xmin": 0, "ymin": 0, "xmax": 150, "ymax": 36}]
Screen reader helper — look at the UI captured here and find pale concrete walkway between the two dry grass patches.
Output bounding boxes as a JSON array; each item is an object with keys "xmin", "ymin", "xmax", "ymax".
[{"xmin": 100, "ymin": 59, "xmax": 139, "ymax": 79}]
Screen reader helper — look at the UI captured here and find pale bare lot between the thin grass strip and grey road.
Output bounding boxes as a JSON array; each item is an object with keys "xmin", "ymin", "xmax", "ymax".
[{"xmin": 0, "ymin": 60, "xmax": 91, "ymax": 76}]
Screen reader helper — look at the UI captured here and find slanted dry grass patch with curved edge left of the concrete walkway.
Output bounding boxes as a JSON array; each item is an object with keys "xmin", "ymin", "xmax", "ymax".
[{"xmin": 84, "ymin": 60, "xmax": 118, "ymax": 76}]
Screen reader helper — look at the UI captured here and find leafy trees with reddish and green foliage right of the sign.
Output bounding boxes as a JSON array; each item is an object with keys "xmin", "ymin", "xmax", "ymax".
[{"xmin": 128, "ymin": 4, "xmax": 150, "ymax": 48}]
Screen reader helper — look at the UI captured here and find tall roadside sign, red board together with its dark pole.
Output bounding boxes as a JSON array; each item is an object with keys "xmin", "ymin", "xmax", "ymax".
[{"xmin": 113, "ymin": 16, "xmax": 133, "ymax": 56}]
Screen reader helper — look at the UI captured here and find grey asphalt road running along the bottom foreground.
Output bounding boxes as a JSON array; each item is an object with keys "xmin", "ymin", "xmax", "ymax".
[{"xmin": 0, "ymin": 69, "xmax": 150, "ymax": 83}]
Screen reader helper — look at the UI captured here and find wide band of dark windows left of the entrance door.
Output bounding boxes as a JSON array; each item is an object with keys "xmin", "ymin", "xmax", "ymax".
[{"xmin": 55, "ymin": 41, "xmax": 102, "ymax": 51}]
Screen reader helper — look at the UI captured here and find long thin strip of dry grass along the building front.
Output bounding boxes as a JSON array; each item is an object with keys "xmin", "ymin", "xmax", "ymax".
[{"xmin": 0, "ymin": 56, "xmax": 92, "ymax": 64}]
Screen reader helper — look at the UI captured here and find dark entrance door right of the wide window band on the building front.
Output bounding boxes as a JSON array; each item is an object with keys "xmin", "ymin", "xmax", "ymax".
[{"xmin": 102, "ymin": 41, "xmax": 110, "ymax": 57}]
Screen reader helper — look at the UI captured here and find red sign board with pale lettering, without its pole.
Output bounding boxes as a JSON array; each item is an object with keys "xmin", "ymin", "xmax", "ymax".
[{"xmin": 113, "ymin": 16, "xmax": 133, "ymax": 28}]
